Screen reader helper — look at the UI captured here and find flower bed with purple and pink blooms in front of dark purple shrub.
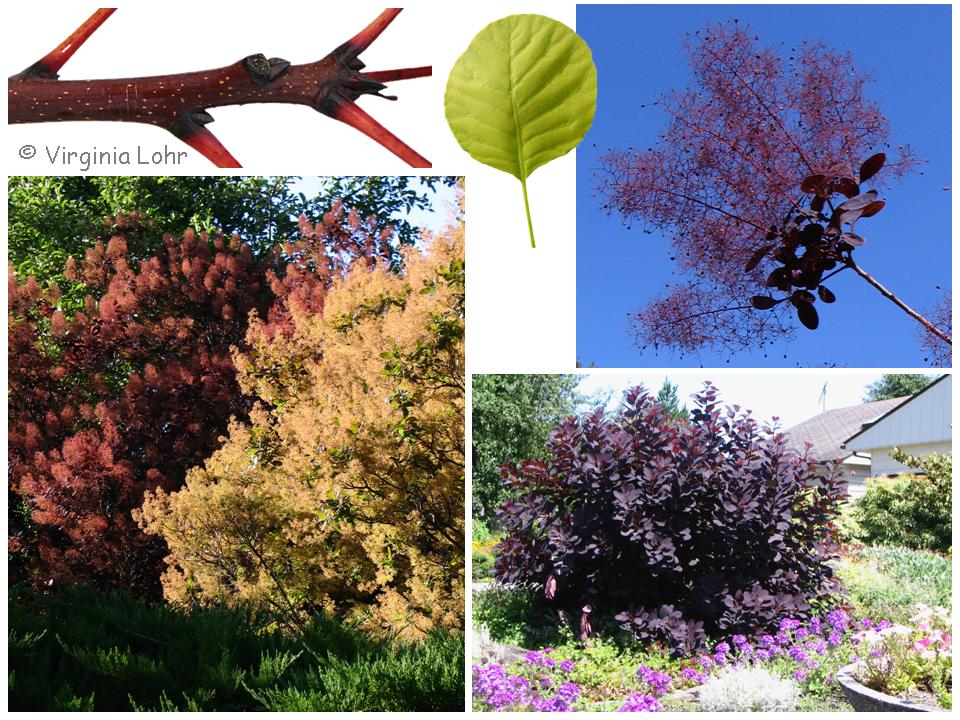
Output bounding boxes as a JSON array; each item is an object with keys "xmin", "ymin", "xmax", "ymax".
[{"xmin": 473, "ymin": 606, "xmax": 952, "ymax": 712}]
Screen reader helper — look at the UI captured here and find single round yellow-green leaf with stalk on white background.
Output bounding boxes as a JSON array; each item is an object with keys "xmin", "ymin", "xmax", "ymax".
[{"xmin": 444, "ymin": 15, "xmax": 597, "ymax": 247}]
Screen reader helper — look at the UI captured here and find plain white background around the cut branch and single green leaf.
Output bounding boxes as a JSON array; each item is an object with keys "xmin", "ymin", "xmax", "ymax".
[{"xmin": 2, "ymin": 1, "xmax": 576, "ymax": 373}]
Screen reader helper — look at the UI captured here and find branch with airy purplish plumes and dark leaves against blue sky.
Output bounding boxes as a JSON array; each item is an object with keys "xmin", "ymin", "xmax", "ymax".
[{"xmin": 595, "ymin": 20, "xmax": 951, "ymax": 358}]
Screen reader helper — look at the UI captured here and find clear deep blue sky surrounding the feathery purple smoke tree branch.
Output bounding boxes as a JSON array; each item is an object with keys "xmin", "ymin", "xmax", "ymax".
[{"xmin": 577, "ymin": 5, "xmax": 953, "ymax": 368}]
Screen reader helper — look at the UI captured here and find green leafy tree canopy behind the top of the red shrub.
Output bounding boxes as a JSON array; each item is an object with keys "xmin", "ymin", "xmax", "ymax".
[{"xmin": 7, "ymin": 175, "xmax": 456, "ymax": 285}]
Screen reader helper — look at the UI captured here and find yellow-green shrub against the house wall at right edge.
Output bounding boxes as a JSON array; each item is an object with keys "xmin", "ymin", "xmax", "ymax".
[{"xmin": 853, "ymin": 450, "xmax": 953, "ymax": 551}]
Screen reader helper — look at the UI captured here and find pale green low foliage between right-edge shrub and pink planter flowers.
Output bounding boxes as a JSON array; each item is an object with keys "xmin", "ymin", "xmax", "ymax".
[{"xmin": 838, "ymin": 547, "xmax": 953, "ymax": 622}]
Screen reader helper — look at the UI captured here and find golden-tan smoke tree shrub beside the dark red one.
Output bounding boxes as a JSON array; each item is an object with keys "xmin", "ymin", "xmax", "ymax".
[{"xmin": 138, "ymin": 208, "xmax": 464, "ymax": 638}]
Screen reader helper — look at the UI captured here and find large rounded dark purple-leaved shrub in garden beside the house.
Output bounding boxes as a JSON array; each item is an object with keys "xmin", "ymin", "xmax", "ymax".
[{"xmin": 496, "ymin": 383, "xmax": 846, "ymax": 652}]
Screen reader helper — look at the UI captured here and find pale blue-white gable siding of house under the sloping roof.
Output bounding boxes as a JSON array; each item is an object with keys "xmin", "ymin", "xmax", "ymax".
[{"xmin": 845, "ymin": 375, "xmax": 953, "ymax": 450}]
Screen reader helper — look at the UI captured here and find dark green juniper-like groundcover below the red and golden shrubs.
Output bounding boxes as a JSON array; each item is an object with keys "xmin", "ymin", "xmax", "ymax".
[{"xmin": 8, "ymin": 589, "xmax": 464, "ymax": 712}]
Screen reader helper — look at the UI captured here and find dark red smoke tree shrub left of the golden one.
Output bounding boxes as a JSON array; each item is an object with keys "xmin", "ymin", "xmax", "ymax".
[{"xmin": 8, "ymin": 203, "xmax": 387, "ymax": 595}]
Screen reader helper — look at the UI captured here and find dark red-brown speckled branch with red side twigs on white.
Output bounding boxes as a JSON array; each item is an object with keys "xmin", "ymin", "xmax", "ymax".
[{"xmin": 7, "ymin": 8, "xmax": 432, "ymax": 168}]
